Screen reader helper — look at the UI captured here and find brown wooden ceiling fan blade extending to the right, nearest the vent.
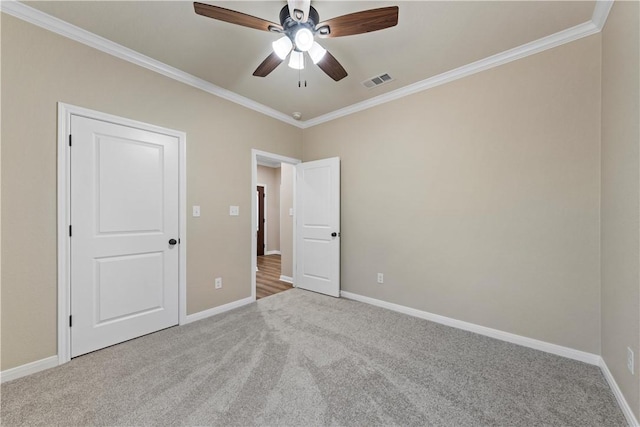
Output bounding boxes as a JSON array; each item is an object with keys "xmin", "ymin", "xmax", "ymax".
[{"xmin": 316, "ymin": 6, "xmax": 398, "ymax": 37}]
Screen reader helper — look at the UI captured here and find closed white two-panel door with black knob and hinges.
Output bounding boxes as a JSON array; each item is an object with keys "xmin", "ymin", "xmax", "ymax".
[{"xmin": 71, "ymin": 116, "xmax": 179, "ymax": 357}]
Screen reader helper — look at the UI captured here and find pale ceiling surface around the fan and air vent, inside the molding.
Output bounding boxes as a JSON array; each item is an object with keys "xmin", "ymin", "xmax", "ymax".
[{"xmin": 24, "ymin": 0, "xmax": 596, "ymax": 121}]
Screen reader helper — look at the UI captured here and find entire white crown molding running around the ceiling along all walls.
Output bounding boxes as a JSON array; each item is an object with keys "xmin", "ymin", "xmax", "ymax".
[{"xmin": 0, "ymin": 0, "xmax": 613, "ymax": 129}]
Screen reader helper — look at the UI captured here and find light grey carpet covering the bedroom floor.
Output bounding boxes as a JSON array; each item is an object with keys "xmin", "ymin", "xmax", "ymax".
[{"xmin": 1, "ymin": 289, "xmax": 626, "ymax": 427}]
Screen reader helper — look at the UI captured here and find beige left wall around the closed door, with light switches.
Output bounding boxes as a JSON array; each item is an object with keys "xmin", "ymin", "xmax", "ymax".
[{"xmin": 1, "ymin": 14, "xmax": 301, "ymax": 370}]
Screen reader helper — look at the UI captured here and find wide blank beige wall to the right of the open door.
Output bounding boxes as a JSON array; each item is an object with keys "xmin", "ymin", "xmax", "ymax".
[{"xmin": 303, "ymin": 35, "xmax": 600, "ymax": 354}]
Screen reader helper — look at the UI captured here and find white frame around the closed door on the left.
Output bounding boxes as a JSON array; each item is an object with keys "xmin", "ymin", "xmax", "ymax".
[{"xmin": 58, "ymin": 102, "xmax": 187, "ymax": 365}]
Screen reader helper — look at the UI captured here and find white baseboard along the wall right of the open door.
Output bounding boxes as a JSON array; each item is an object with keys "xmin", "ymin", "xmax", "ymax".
[{"xmin": 340, "ymin": 291, "xmax": 601, "ymax": 366}]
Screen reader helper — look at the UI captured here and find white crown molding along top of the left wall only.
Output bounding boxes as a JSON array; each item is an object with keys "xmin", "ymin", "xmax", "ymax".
[{"xmin": 0, "ymin": 0, "xmax": 301, "ymax": 127}]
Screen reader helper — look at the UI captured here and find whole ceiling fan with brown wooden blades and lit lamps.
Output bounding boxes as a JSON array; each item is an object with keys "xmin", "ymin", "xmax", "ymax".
[{"xmin": 193, "ymin": 0, "xmax": 398, "ymax": 81}]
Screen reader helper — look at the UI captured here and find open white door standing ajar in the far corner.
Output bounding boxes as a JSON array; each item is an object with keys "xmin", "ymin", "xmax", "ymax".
[{"xmin": 295, "ymin": 157, "xmax": 340, "ymax": 297}]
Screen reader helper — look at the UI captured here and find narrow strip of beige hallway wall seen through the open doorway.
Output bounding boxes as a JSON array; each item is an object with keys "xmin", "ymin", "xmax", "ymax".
[{"xmin": 280, "ymin": 163, "xmax": 295, "ymax": 278}]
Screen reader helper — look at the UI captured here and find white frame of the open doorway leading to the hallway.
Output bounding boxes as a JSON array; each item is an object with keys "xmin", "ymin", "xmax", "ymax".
[{"xmin": 251, "ymin": 148, "xmax": 302, "ymax": 301}]
